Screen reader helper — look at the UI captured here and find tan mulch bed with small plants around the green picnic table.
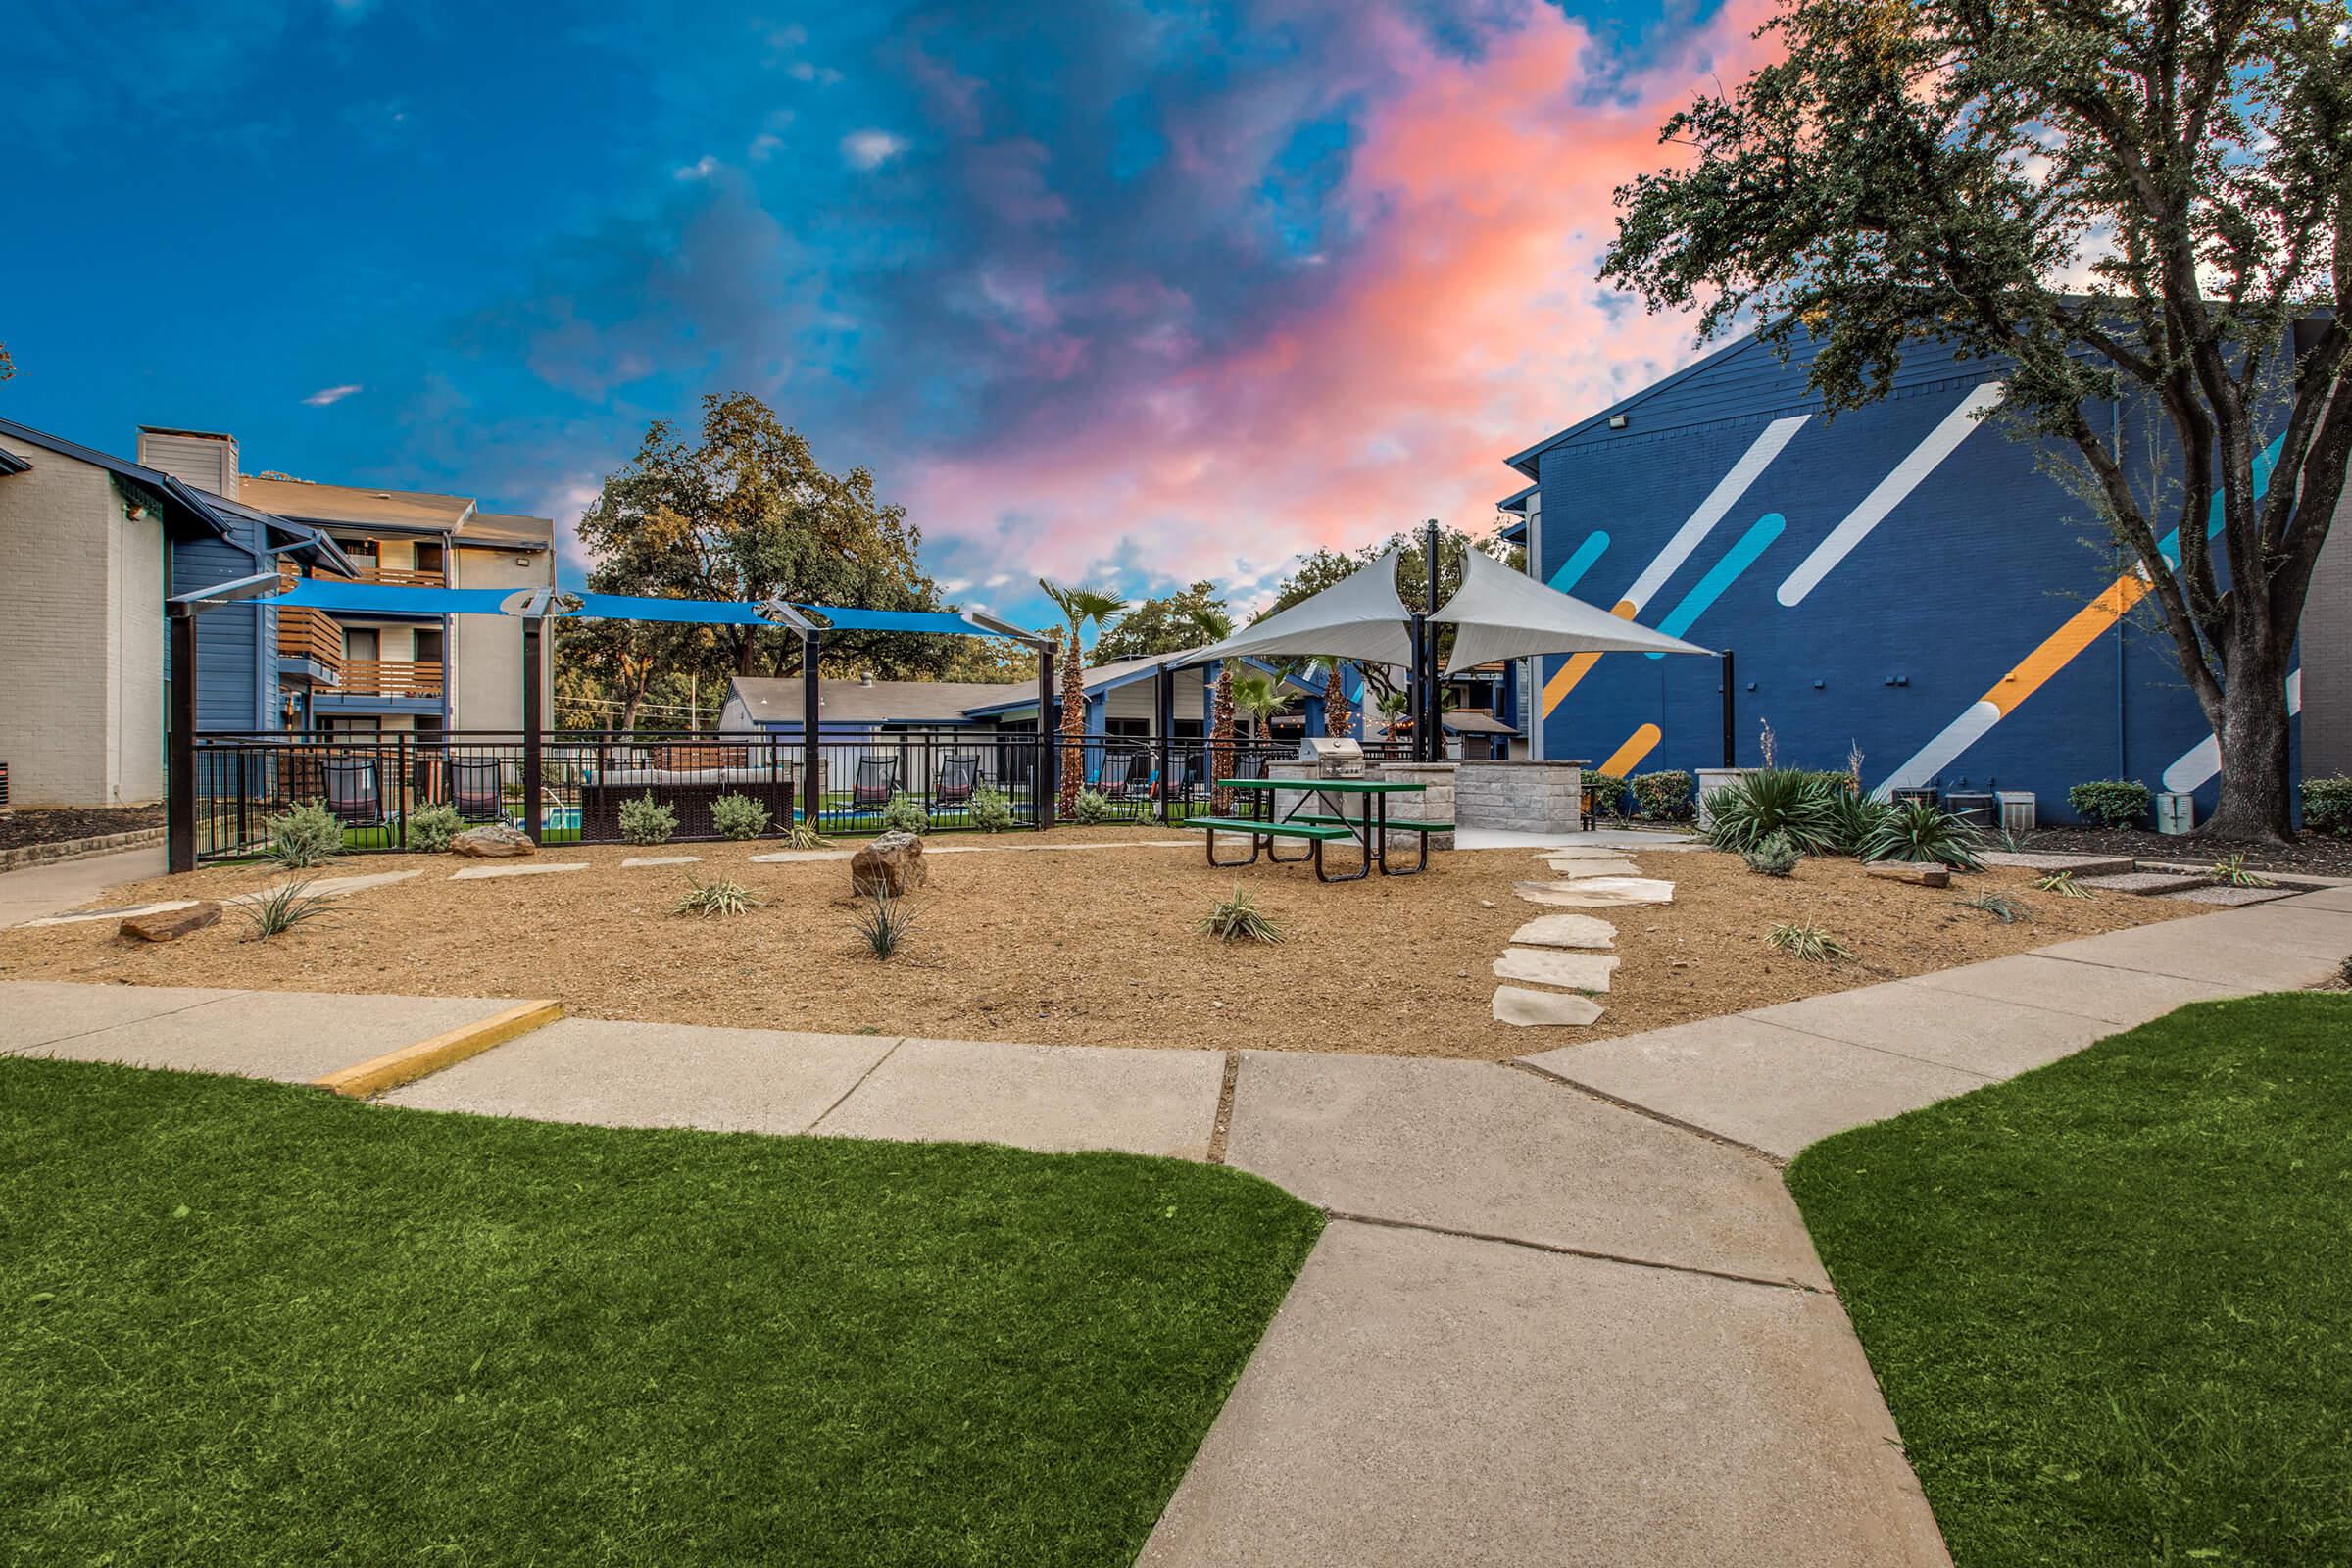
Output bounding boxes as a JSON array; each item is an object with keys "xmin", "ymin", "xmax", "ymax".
[{"xmin": 0, "ymin": 827, "xmax": 2182, "ymax": 1060}]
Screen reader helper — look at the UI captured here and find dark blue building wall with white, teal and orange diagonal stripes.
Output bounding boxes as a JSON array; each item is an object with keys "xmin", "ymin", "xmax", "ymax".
[{"xmin": 1500, "ymin": 336, "xmax": 2352, "ymax": 820}]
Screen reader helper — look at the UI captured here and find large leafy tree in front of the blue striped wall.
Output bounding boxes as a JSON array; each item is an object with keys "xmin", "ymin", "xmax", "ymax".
[{"xmin": 1601, "ymin": 0, "xmax": 2352, "ymax": 837}]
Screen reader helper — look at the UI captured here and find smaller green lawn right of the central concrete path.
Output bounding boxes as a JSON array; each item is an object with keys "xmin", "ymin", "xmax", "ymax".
[{"xmin": 1788, "ymin": 992, "xmax": 2352, "ymax": 1568}]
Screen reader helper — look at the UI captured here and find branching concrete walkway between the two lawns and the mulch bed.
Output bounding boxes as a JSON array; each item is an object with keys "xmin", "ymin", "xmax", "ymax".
[{"xmin": 0, "ymin": 889, "xmax": 2352, "ymax": 1568}]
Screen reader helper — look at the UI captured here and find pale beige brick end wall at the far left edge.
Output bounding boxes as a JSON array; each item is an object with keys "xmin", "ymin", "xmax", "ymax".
[{"xmin": 0, "ymin": 449, "xmax": 163, "ymax": 807}]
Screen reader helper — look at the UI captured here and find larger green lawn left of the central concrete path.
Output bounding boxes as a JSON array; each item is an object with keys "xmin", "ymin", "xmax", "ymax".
[{"xmin": 0, "ymin": 1060, "xmax": 1322, "ymax": 1568}]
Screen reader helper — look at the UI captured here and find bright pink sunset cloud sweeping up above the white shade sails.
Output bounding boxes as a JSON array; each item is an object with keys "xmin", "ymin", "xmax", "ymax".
[{"xmin": 906, "ymin": 0, "xmax": 1764, "ymax": 578}]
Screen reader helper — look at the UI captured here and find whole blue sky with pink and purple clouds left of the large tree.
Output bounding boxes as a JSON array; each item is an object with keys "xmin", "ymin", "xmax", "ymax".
[{"xmin": 0, "ymin": 0, "xmax": 1762, "ymax": 623}]
